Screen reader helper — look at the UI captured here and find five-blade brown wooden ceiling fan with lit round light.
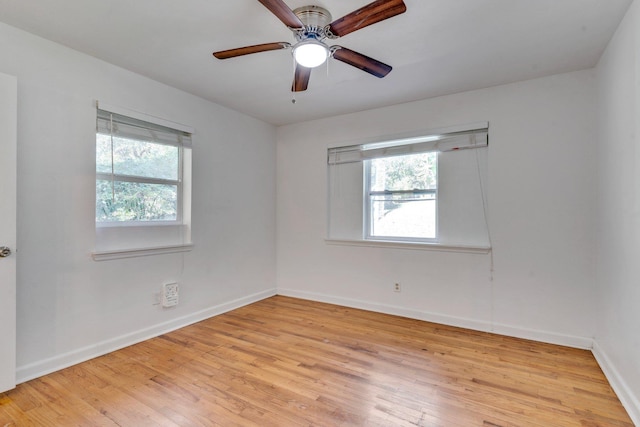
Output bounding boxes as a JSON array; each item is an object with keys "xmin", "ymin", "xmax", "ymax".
[{"xmin": 213, "ymin": 0, "xmax": 407, "ymax": 92}]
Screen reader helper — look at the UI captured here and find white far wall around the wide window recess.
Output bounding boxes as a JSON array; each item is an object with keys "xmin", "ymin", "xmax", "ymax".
[{"xmin": 277, "ymin": 71, "xmax": 596, "ymax": 347}]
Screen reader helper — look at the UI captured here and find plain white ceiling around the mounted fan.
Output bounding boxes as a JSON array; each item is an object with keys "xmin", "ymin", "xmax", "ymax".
[{"xmin": 0, "ymin": 0, "xmax": 632, "ymax": 125}]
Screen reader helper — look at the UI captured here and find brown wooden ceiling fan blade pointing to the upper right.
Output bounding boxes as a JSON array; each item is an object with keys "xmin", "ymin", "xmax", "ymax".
[{"xmin": 329, "ymin": 0, "xmax": 407, "ymax": 37}]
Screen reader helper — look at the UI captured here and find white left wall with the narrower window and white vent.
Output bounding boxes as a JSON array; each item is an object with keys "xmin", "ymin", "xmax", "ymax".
[{"xmin": 0, "ymin": 24, "xmax": 276, "ymax": 381}]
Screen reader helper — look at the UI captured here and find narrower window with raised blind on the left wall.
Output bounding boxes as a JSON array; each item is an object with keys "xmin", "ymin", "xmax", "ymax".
[{"xmin": 94, "ymin": 105, "xmax": 191, "ymax": 258}]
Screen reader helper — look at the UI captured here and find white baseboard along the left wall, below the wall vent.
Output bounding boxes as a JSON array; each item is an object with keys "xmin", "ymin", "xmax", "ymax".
[{"xmin": 16, "ymin": 289, "xmax": 276, "ymax": 384}]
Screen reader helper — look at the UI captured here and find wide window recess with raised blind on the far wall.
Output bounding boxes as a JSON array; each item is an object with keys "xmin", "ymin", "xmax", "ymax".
[{"xmin": 327, "ymin": 123, "xmax": 490, "ymax": 249}]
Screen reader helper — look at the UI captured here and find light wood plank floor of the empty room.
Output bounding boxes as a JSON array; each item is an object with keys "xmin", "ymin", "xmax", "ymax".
[{"xmin": 0, "ymin": 296, "xmax": 633, "ymax": 427}]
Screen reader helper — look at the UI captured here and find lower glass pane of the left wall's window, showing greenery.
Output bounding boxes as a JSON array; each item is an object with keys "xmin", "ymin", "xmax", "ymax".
[{"xmin": 96, "ymin": 180, "xmax": 178, "ymax": 222}]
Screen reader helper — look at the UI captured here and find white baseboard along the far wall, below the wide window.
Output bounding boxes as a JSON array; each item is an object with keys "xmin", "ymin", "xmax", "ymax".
[{"xmin": 278, "ymin": 288, "xmax": 593, "ymax": 350}]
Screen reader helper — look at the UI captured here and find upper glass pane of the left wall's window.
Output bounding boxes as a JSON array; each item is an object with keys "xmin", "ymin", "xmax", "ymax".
[{"xmin": 96, "ymin": 134, "xmax": 180, "ymax": 181}]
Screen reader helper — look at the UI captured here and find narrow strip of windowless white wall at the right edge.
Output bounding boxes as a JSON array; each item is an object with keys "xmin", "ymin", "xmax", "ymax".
[{"xmin": 594, "ymin": 2, "xmax": 640, "ymax": 425}]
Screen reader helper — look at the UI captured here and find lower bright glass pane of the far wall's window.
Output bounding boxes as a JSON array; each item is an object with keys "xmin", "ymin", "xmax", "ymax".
[{"xmin": 371, "ymin": 194, "xmax": 436, "ymax": 239}]
